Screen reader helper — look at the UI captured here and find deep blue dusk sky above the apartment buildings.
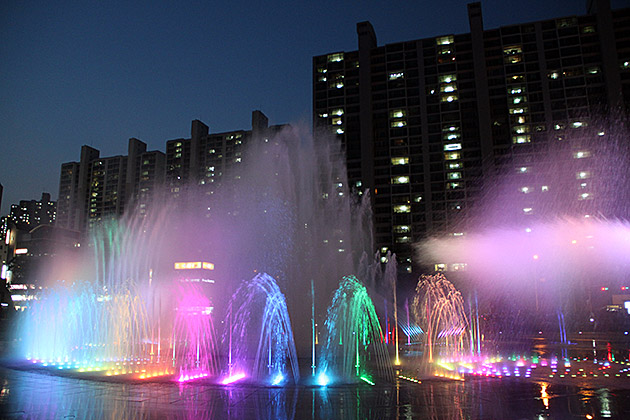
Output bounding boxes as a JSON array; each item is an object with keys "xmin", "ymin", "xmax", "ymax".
[{"xmin": 0, "ymin": 0, "xmax": 627, "ymax": 215}]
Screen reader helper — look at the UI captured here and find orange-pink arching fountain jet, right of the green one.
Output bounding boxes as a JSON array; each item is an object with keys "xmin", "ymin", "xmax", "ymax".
[{"xmin": 413, "ymin": 274, "xmax": 468, "ymax": 363}]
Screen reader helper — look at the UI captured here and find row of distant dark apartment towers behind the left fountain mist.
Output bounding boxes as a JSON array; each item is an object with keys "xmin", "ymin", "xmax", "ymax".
[{"xmin": 57, "ymin": 111, "xmax": 284, "ymax": 232}]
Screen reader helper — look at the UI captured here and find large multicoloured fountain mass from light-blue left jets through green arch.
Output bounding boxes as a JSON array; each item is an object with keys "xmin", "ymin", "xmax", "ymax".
[{"xmin": 9, "ymin": 128, "xmax": 397, "ymax": 386}]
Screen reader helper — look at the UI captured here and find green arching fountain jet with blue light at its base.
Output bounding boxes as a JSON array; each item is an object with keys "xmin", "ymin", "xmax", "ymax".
[{"xmin": 318, "ymin": 276, "xmax": 392, "ymax": 385}]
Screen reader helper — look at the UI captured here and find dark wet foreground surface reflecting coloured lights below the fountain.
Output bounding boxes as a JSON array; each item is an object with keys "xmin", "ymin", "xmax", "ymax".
[{"xmin": 0, "ymin": 368, "xmax": 630, "ymax": 420}]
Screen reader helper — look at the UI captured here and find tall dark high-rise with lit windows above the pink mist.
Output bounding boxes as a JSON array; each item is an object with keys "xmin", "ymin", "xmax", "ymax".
[{"xmin": 313, "ymin": 0, "xmax": 630, "ymax": 271}]
